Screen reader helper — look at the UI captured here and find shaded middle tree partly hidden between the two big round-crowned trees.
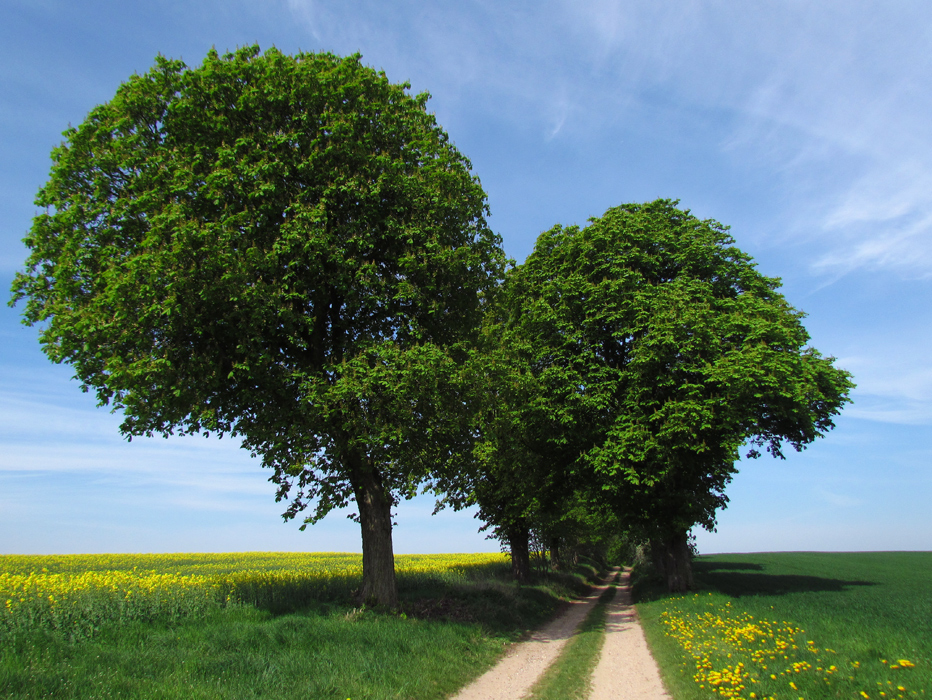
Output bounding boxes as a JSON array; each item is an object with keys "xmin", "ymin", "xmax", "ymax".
[{"xmin": 442, "ymin": 266, "xmax": 606, "ymax": 583}]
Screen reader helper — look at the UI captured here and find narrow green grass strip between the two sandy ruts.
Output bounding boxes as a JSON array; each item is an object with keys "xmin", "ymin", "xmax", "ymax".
[{"xmin": 528, "ymin": 573, "xmax": 620, "ymax": 700}]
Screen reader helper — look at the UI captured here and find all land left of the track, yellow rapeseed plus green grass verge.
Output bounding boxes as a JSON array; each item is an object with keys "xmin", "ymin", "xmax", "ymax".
[{"xmin": 0, "ymin": 553, "xmax": 595, "ymax": 700}]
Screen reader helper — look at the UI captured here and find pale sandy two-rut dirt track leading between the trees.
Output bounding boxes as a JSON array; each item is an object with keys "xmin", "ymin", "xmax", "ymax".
[{"xmin": 452, "ymin": 571, "xmax": 670, "ymax": 700}]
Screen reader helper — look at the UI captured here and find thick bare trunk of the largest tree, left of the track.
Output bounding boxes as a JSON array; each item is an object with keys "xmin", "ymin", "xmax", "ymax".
[{"xmin": 350, "ymin": 455, "xmax": 398, "ymax": 608}]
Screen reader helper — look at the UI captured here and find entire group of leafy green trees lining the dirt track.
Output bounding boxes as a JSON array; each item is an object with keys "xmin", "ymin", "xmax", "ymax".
[{"xmin": 11, "ymin": 47, "xmax": 852, "ymax": 605}]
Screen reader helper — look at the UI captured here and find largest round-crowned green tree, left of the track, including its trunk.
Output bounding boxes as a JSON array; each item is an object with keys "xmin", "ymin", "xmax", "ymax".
[{"xmin": 11, "ymin": 47, "xmax": 504, "ymax": 605}]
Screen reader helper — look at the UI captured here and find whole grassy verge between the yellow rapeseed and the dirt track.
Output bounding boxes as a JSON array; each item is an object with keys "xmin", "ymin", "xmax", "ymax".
[{"xmin": 0, "ymin": 556, "xmax": 592, "ymax": 700}]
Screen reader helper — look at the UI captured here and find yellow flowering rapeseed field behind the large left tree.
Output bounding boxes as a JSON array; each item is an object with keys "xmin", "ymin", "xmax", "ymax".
[{"xmin": 0, "ymin": 552, "xmax": 506, "ymax": 639}]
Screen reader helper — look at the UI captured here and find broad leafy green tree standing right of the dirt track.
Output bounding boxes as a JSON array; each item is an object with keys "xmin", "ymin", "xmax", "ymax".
[{"xmin": 508, "ymin": 200, "xmax": 853, "ymax": 590}]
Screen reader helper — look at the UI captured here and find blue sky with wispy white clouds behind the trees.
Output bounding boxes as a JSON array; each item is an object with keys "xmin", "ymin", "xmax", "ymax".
[{"xmin": 0, "ymin": 0, "xmax": 932, "ymax": 553}]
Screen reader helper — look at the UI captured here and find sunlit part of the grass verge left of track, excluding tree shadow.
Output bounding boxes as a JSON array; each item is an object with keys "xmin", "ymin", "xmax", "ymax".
[{"xmin": 0, "ymin": 608, "xmax": 501, "ymax": 700}]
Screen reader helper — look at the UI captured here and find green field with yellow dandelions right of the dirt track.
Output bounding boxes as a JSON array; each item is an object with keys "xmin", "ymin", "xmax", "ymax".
[{"xmin": 635, "ymin": 552, "xmax": 932, "ymax": 700}]
